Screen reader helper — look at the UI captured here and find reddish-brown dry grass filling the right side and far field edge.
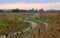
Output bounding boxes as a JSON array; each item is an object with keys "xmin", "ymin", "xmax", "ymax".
[{"xmin": 0, "ymin": 12, "xmax": 60, "ymax": 38}]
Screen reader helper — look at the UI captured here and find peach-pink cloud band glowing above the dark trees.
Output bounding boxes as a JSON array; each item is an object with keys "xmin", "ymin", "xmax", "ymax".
[{"xmin": 0, "ymin": 2, "xmax": 60, "ymax": 9}]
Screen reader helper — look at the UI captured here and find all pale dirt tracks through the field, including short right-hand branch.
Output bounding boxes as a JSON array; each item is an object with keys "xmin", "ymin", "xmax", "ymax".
[{"xmin": 0, "ymin": 18, "xmax": 48, "ymax": 38}]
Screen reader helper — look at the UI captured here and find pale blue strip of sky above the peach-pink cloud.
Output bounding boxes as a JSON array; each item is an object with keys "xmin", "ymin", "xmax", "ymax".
[{"xmin": 0, "ymin": 0, "xmax": 60, "ymax": 4}]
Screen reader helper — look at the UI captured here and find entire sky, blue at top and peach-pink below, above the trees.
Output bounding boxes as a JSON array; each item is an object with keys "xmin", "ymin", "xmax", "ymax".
[{"xmin": 0, "ymin": 0, "xmax": 60, "ymax": 10}]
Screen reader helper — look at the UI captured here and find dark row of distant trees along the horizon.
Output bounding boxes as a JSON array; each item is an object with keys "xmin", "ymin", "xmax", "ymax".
[{"xmin": 0, "ymin": 8, "xmax": 60, "ymax": 13}]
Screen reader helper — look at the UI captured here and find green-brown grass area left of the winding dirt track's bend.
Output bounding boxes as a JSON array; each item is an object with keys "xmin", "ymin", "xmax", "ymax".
[{"xmin": 0, "ymin": 14, "xmax": 30, "ymax": 34}]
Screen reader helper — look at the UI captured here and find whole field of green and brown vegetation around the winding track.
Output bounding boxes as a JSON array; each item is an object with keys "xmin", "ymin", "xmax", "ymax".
[{"xmin": 0, "ymin": 12, "xmax": 60, "ymax": 38}]
